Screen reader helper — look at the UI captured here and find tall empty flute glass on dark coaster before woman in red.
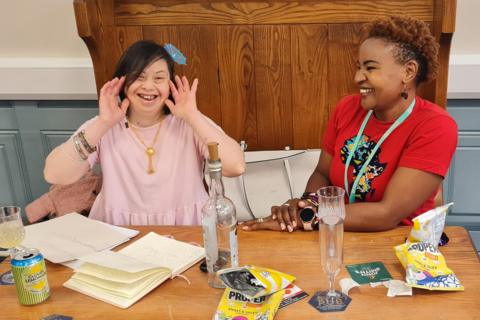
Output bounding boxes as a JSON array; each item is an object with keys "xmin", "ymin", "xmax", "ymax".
[{"xmin": 317, "ymin": 187, "xmax": 345, "ymax": 305}]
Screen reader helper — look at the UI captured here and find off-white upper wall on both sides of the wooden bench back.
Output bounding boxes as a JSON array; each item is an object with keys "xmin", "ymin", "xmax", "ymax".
[{"xmin": 0, "ymin": 0, "xmax": 480, "ymax": 99}]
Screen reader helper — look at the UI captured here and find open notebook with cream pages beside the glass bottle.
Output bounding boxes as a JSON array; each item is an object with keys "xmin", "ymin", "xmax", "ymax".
[{"xmin": 63, "ymin": 232, "xmax": 205, "ymax": 308}]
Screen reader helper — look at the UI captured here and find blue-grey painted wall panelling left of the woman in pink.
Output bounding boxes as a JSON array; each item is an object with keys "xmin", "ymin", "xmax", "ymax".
[{"xmin": 0, "ymin": 101, "xmax": 98, "ymax": 221}]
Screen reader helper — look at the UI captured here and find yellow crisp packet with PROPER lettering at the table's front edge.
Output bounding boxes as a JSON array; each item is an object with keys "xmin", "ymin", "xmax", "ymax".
[{"xmin": 213, "ymin": 288, "xmax": 285, "ymax": 320}]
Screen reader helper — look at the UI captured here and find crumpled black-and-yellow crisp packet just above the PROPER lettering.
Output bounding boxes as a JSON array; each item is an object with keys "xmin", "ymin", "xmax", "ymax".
[{"xmin": 218, "ymin": 266, "xmax": 295, "ymax": 299}]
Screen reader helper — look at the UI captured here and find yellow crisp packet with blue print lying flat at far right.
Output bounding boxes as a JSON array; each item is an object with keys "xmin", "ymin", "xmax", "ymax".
[{"xmin": 394, "ymin": 242, "xmax": 464, "ymax": 291}]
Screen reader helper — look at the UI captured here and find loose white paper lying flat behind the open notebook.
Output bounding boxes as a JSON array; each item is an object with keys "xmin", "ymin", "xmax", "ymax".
[{"xmin": 22, "ymin": 213, "xmax": 129, "ymax": 263}]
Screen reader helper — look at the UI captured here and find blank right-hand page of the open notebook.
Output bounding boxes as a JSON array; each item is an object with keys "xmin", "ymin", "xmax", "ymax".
[{"xmin": 119, "ymin": 232, "xmax": 205, "ymax": 276}]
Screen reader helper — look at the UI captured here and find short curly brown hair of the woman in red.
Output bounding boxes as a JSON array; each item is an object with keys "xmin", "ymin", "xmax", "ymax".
[{"xmin": 362, "ymin": 16, "xmax": 439, "ymax": 85}]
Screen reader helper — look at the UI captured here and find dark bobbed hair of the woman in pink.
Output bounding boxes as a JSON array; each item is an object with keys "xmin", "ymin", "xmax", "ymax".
[{"xmin": 113, "ymin": 40, "xmax": 175, "ymax": 114}]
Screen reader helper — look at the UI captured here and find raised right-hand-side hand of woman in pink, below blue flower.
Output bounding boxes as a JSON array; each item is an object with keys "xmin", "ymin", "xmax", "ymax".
[{"xmin": 165, "ymin": 76, "xmax": 198, "ymax": 120}]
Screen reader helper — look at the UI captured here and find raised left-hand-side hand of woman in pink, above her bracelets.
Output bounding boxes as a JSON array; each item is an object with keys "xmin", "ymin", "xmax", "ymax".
[{"xmin": 98, "ymin": 76, "xmax": 130, "ymax": 128}]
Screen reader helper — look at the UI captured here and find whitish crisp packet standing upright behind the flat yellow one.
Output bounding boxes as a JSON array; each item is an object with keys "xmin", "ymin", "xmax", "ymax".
[{"xmin": 407, "ymin": 202, "xmax": 453, "ymax": 247}]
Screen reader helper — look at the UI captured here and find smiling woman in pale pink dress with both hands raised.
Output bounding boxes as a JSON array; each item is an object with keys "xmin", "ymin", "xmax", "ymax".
[{"xmin": 44, "ymin": 41, "xmax": 245, "ymax": 225}]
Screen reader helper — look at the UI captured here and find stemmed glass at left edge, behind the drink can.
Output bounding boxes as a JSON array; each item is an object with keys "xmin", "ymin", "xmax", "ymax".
[{"xmin": 0, "ymin": 206, "xmax": 25, "ymax": 283}]
